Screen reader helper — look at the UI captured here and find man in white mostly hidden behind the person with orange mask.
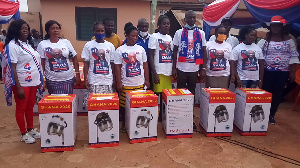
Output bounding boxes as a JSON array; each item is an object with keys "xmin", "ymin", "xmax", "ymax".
[{"xmin": 209, "ymin": 18, "xmax": 239, "ymax": 48}]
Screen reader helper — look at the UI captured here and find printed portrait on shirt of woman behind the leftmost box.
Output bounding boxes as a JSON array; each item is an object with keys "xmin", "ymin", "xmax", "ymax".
[{"xmin": 46, "ymin": 47, "xmax": 69, "ymax": 72}]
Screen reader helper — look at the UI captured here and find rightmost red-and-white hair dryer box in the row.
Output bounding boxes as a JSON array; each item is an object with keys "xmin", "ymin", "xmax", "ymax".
[{"xmin": 234, "ymin": 88, "xmax": 272, "ymax": 136}]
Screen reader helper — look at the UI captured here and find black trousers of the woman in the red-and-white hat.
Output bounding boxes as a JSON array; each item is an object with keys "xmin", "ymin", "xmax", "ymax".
[{"xmin": 263, "ymin": 70, "xmax": 290, "ymax": 117}]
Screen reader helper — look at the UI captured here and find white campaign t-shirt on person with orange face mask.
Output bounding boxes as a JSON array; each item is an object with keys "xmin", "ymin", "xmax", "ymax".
[{"xmin": 206, "ymin": 41, "xmax": 232, "ymax": 76}]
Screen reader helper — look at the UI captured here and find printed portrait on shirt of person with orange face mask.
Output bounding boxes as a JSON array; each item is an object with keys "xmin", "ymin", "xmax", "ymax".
[{"xmin": 210, "ymin": 49, "xmax": 227, "ymax": 71}]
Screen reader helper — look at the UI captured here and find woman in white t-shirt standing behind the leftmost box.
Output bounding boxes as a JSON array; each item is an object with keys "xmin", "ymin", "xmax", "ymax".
[{"xmin": 38, "ymin": 20, "xmax": 80, "ymax": 94}]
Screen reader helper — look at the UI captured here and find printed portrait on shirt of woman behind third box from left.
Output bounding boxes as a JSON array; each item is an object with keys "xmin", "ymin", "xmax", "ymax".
[{"xmin": 122, "ymin": 52, "xmax": 141, "ymax": 77}]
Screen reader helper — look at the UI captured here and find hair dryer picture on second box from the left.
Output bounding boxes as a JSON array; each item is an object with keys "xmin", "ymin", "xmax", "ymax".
[{"xmin": 94, "ymin": 112, "xmax": 113, "ymax": 143}]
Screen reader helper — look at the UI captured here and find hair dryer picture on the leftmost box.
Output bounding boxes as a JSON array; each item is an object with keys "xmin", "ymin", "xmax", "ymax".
[{"xmin": 46, "ymin": 115, "xmax": 67, "ymax": 145}]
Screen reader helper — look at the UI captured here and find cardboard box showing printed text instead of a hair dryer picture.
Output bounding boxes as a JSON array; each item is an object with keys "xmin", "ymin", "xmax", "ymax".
[{"xmin": 161, "ymin": 89, "xmax": 194, "ymax": 139}]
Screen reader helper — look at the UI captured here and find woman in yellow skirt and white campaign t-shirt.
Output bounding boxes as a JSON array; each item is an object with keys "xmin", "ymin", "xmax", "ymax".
[{"xmin": 148, "ymin": 15, "xmax": 172, "ymax": 121}]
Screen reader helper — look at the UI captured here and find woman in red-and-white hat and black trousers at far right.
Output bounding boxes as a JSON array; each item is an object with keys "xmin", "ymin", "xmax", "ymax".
[{"xmin": 257, "ymin": 16, "xmax": 299, "ymax": 124}]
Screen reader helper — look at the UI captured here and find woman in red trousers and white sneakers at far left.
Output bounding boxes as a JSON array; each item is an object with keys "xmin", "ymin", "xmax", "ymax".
[{"xmin": 3, "ymin": 19, "xmax": 43, "ymax": 143}]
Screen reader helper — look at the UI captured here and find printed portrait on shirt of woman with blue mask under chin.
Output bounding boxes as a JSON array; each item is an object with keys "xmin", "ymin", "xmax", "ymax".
[{"xmin": 91, "ymin": 48, "xmax": 109, "ymax": 75}]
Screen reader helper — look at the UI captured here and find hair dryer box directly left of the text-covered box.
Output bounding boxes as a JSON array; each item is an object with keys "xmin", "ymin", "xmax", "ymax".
[{"xmin": 125, "ymin": 90, "xmax": 158, "ymax": 143}]
